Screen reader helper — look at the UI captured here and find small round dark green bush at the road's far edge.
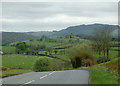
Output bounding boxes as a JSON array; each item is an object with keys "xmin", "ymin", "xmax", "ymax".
[{"xmin": 33, "ymin": 58, "xmax": 50, "ymax": 72}]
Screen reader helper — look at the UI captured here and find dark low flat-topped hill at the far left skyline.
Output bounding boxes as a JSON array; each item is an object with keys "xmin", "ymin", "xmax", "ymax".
[{"xmin": 0, "ymin": 32, "xmax": 37, "ymax": 44}]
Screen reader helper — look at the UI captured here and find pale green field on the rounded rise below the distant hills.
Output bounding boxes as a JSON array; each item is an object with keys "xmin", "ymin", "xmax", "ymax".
[{"xmin": 10, "ymin": 37, "xmax": 90, "ymax": 47}]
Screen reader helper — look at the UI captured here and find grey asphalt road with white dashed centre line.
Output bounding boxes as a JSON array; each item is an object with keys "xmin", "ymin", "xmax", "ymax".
[{"xmin": 2, "ymin": 70, "xmax": 89, "ymax": 85}]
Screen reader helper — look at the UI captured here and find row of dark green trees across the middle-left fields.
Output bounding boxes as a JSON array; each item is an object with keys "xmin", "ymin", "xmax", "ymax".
[{"xmin": 15, "ymin": 42, "xmax": 65, "ymax": 55}]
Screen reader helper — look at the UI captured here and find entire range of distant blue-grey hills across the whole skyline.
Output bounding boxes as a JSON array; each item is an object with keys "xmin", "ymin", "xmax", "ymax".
[{"xmin": 0, "ymin": 24, "xmax": 118, "ymax": 43}]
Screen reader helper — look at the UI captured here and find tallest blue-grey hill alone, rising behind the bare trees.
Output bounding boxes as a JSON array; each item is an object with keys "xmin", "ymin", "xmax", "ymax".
[{"xmin": 48, "ymin": 24, "xmax": 118, "ymax": 37}]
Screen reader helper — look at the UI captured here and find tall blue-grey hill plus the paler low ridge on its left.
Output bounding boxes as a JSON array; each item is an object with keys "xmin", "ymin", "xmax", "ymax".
[{"xmin": 27, "ymin": 23, "xmax": 118, "ymax": 38}]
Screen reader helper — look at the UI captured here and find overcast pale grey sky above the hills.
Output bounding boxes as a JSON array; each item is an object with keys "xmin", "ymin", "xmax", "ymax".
[{"xmin": 0, "ymin": 0, "xmax": 118, "ymax": 32}]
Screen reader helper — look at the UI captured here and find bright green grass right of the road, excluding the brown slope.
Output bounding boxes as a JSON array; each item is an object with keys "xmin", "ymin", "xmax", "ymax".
[{"xmin": 78, "ymin": 66, "xmax": 118, "ymax": 84}]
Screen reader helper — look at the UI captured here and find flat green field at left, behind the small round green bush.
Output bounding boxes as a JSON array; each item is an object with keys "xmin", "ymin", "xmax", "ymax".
[{"xmin": 2, "ymin": 54, "xmax": 61, "ymax": 70}]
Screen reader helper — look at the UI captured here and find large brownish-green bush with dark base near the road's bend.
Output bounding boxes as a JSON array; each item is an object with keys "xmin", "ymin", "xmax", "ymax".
[{"xmin": 69, "ymin": 45, "xmax": 96, "ymax": 68}]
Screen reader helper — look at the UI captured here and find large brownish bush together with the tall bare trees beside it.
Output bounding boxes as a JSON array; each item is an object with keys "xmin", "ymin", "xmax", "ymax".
[{"xmin": 69, "ymin": 28, "xmax": 112, "ymax": 68}]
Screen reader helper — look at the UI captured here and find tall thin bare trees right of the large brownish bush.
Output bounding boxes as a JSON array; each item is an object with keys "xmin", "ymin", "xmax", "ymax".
[{"xmin": 92, "ymin": 28, "xmax": 112, "ymax": 58}]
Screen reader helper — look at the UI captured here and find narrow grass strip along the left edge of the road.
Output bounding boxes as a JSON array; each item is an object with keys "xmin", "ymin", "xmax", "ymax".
[{"xmin": 0, "ymin": 69, "xmax": 32, "ymax": 78}]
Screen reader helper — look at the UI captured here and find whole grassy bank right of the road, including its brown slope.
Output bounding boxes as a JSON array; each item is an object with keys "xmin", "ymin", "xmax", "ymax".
[{"xmin": 79, "ymin": 57, "xmax": 120, "ymax": 84}]
